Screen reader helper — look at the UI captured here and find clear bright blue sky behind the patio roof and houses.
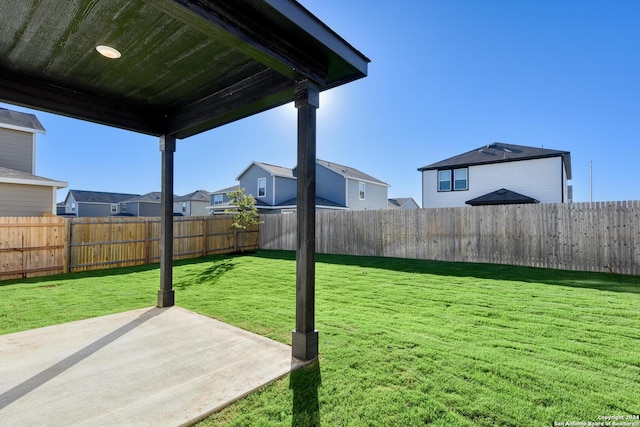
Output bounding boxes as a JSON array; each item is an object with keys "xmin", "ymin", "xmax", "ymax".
[{"xmin": 0, "ymin": 0, "xmax": 640, "ymax": 203}]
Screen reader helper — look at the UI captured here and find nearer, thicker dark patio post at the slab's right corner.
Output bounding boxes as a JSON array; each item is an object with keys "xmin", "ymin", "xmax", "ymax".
[{"xmin": 292, "ymin": 80, "xmax": 320, "ymax": 361}]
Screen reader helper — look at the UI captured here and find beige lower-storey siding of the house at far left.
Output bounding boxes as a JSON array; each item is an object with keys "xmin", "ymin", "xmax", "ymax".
[{"xmin": 0, "ymin": 183, "xmax": 55, "ymax": 216}]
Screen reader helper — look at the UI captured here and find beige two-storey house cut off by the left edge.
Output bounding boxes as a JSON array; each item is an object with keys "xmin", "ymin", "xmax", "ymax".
[{"xmin": 0, "ymin": 108, "xmax": 67, "ymax": 216}]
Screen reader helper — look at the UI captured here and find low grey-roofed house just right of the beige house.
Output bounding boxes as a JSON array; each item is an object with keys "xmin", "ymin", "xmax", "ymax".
[{"xmin": 64, "ymin": 190, "xmax": 140, "ymax": 217}]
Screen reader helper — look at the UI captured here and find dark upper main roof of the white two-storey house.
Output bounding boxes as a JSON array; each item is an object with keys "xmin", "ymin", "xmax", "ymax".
[{"xmin": 418, "ymin": 142, "xmax": 571, "ymax": 179}]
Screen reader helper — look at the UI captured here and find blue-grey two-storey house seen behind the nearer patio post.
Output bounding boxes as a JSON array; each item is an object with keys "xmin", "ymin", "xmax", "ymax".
[{"xmin": 220, "ymin": 159, "xmax": 389, "ymax": 213}]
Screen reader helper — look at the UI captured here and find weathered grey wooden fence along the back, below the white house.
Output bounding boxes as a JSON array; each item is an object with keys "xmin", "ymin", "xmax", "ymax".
[{"xmin": 260, "ymin": 201, "xmax": 640, "ymax": 275}]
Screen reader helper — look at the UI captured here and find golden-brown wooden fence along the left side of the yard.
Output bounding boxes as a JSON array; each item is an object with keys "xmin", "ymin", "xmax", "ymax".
[{"xmin": 0, "ymin": 215, "xmax": 259, "ymax": 280}]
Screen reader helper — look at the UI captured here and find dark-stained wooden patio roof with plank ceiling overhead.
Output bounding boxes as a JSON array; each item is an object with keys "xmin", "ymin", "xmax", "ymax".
[{"xmin": 0, "ymin": 0, "xmax": 369, "ymax": 138}]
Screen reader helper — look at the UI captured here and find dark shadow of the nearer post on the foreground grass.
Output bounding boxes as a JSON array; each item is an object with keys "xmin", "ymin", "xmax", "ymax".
[{"xmin": 289, "ymin": 360, "xmax": 322, "ymax": 427}]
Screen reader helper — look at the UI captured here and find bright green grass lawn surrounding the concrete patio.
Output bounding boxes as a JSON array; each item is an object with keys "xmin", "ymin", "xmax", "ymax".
[{"xmin": 0, "ymin": 251, "xmax": 640, "ymax": 427}]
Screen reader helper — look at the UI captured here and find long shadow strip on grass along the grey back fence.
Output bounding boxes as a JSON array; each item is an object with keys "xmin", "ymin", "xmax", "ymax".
[{"xmin": 254, "ymin": 250, "xmax": 640, "ymax": 294}]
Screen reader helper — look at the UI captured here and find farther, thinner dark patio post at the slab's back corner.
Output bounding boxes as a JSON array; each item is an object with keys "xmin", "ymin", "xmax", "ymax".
[{"xmin": 158, "ymin": 135, "xmax": 176, "ymax": 307}]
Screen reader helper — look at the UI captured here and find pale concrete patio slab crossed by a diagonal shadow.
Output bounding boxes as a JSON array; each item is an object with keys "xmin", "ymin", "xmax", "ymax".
[{"xmin": 0, "ymin": 307, "xmax": 292, "ymax": 427}]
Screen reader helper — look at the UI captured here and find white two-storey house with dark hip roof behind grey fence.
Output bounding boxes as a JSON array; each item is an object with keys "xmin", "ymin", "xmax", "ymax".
[{"xmin": 418, "ymin": 142, "xmax": 572, "ymax": 208}]
